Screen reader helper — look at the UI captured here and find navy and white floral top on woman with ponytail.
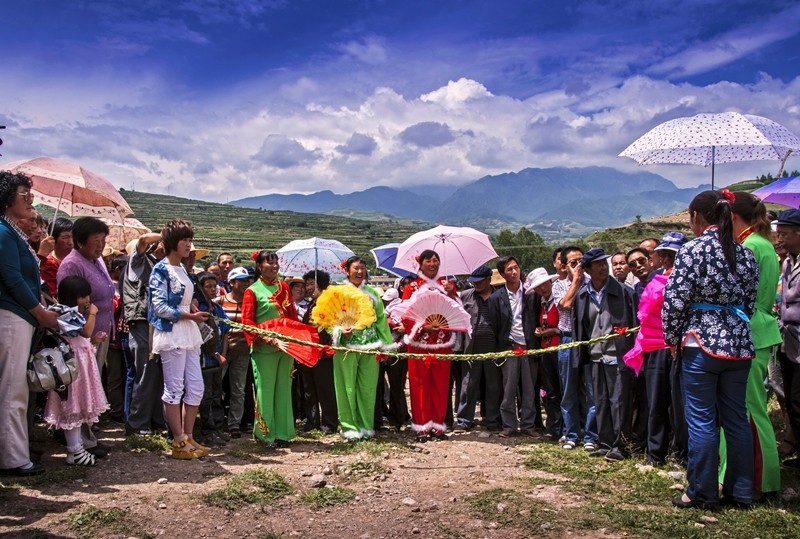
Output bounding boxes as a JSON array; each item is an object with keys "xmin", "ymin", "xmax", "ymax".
[{"xmin": 661, "ymin": 226, "xmax": 759, "ymax": 359}]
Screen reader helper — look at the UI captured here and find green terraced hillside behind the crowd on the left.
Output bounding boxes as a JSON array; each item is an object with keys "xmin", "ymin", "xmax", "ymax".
[{"xmin": 120, "ymin": 190, "xmax": 433, "ymax": 266}]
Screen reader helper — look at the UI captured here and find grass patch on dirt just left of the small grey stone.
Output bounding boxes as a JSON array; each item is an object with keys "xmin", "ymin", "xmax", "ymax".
[{"xmin": 201, "ymin": 468, "xmax": 292, "ymax": 511}]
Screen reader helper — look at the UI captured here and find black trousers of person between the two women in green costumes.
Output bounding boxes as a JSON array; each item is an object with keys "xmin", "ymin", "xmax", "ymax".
[{"xmin": 298, "ymin": 356, "xmax": 339, "ymax": 432}]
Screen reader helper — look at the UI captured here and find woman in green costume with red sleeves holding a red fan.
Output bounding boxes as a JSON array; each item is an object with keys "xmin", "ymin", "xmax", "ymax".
[{"xmin": 242, "ymin": 251, "xmax": 297, "ymax": 447}]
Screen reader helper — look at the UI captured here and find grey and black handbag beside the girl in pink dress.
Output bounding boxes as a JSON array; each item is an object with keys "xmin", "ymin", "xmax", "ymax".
[{"xmin": 28, "ymin": 328, "xmax": 78, "ymax": 398}]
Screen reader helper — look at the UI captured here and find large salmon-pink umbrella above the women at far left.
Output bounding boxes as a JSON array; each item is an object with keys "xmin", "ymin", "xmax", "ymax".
[{"xmin": 3, "ymin": 157, "xmax": 133, "ymax": 223}]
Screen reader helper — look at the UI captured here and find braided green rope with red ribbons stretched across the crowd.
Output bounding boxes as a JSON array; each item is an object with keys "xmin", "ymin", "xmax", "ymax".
[{"xmin": 212, "ymin": 316, "xmax": 639, "ymax": 361}]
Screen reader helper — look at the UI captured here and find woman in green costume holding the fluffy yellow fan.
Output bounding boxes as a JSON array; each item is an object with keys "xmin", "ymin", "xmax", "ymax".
[{"xmin": 333, "ymin": 256, "xmax": 392, "ymax": 441}]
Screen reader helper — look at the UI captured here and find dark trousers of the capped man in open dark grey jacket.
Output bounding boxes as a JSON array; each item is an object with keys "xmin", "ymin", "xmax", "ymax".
[{"xmin": 592, "ymin": 362, "xmax": 633, "ymax": 455}]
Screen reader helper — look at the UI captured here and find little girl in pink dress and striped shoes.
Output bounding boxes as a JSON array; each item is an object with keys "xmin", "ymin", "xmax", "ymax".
[{"xmin": 44, "ymin": 275, "xmax": 108, "ymax": 466}]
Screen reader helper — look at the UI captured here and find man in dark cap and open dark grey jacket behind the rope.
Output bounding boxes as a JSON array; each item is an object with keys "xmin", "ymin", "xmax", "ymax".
[{"xmin": 573, "ymin": 247, "xmax": 636, "ymax": 460}]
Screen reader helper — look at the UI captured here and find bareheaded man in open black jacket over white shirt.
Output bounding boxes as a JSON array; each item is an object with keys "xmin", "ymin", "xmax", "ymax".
[{"xmin": 489, "ymin": 256, "xmax": 539, "ymax": 438}]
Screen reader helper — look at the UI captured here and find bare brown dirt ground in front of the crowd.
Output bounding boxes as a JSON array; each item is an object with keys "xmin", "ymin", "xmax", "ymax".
[{"xmin": 0, "ymin": 423, "xmax": 612, "ymax": 539}]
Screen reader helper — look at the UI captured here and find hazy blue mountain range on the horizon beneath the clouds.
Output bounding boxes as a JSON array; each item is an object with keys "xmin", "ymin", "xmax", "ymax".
[{"xmin": 230, "ymin": 167, "xmax": 707, "ymax": 235}]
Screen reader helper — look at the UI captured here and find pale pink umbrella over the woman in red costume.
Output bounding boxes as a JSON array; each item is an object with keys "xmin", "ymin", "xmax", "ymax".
[{"xmin": 395, "ymin": 225, "xmax": 497, "ymax": 275}]
